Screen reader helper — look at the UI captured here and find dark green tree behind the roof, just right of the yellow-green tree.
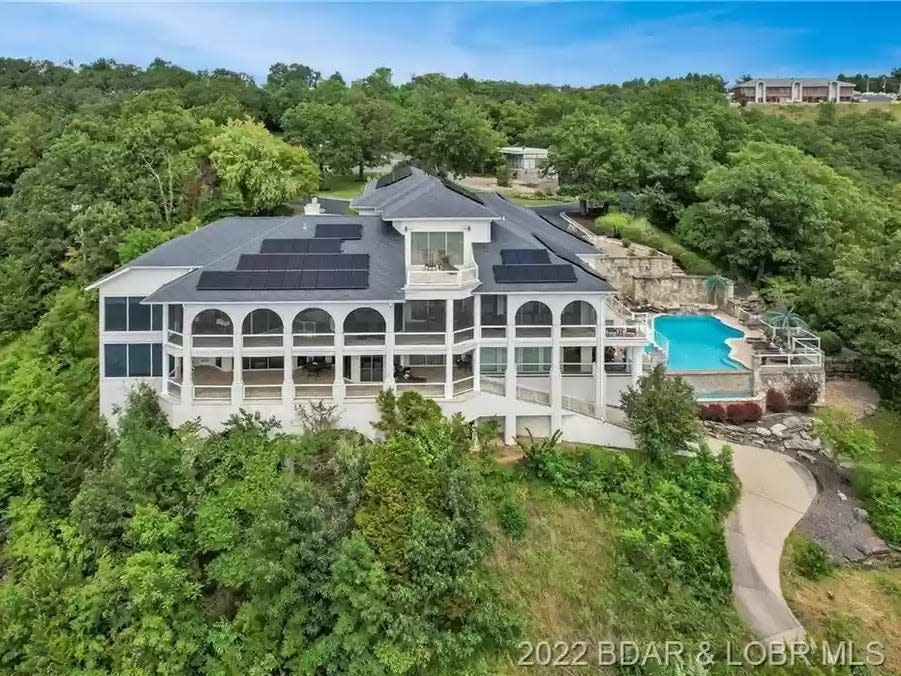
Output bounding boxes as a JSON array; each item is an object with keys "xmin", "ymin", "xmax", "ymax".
[{"xmin": 281, "ymin": 101, "xmax": 363, "ymax": 176}]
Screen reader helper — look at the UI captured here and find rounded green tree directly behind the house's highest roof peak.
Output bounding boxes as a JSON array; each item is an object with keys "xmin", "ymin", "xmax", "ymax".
[{"xmin": 398, "ymin": 93, "xmax": 503, "ymax": 175}]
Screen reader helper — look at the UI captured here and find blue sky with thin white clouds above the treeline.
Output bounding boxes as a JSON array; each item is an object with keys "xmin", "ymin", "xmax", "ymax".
[{"xmin": 0, "ymin": 2, "xmax": 901, "ymax": 85}]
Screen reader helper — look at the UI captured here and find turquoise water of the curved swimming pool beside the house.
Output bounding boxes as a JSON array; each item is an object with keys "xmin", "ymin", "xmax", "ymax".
[{"xmin": 654, "ymin": 315, "xmax": 743, "ymax": 371}]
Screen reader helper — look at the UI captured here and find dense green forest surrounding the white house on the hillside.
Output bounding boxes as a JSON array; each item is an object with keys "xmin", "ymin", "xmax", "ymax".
[{"xmin": 0, "ymin": 59, "xmax": 901, "ymax": 674}]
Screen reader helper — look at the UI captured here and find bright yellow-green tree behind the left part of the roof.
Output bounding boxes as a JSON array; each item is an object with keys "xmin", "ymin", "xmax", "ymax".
[{"xmin": 210, "ymin": 120, "xmax": 319, "ymax": 214}]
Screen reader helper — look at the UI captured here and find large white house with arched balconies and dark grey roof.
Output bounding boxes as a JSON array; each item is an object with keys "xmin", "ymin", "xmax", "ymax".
[{"xmin": 92, "ymin": 169, "xmax": 653, "ymax": 445}]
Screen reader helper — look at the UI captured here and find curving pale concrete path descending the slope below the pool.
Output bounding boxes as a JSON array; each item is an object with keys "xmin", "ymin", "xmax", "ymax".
[{"xmin": 708, "ymin": 439, "xmax": 817, "ymax": 642}]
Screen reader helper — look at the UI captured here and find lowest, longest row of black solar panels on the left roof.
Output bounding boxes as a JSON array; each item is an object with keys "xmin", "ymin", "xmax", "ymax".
[{"xmin": 197, "ymin": 270, "xmax": 369, "ymax": 291}]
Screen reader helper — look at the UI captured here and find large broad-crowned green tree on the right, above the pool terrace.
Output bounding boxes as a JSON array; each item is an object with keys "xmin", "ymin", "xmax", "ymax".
[{"xmin": 677, "ymin": 141, "xmax": 882, "ymax": 280}]
